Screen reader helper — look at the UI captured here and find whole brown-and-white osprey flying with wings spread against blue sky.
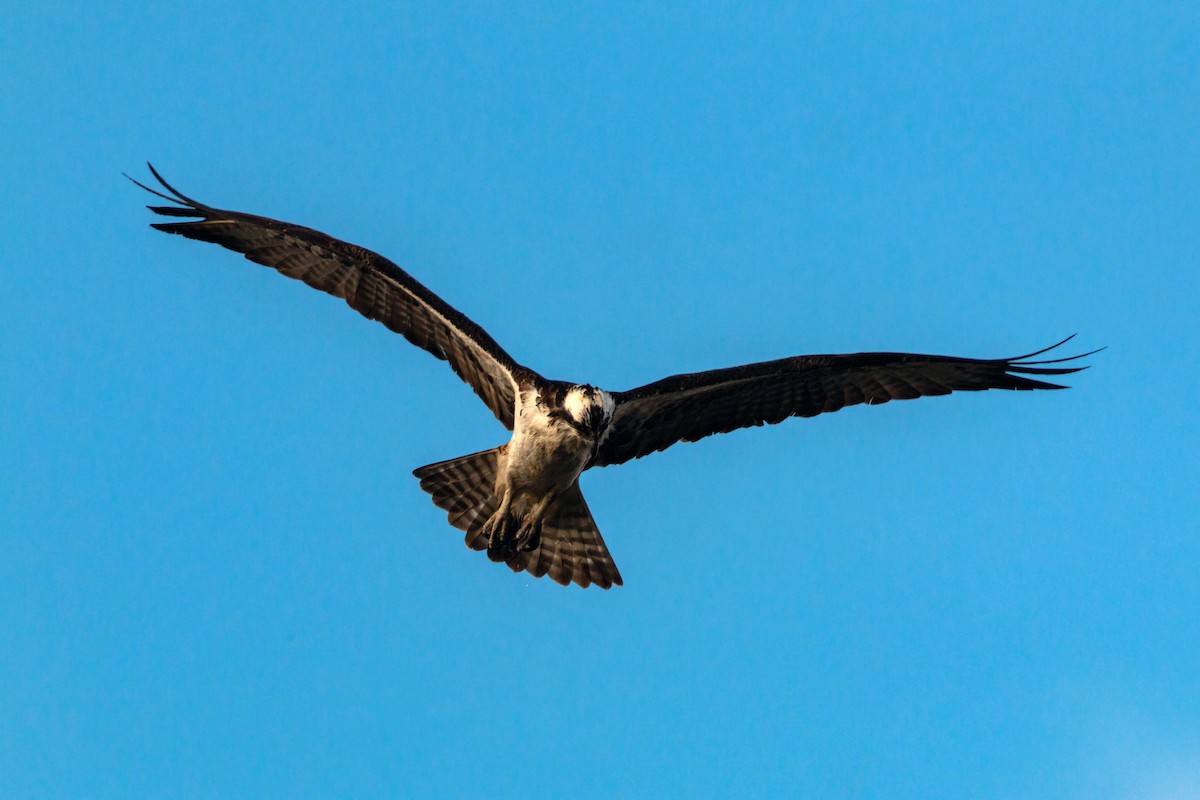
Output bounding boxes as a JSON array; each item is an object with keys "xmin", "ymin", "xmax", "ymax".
[{"xmin": 126, "ymin": 164, "xmax": 1096, "ymax": 589}]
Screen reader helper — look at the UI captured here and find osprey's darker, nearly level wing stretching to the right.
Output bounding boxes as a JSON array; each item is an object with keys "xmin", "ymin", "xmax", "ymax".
[{"xmin": 592, "ymin": 337, "xmax": 1098, "ymax": 467}]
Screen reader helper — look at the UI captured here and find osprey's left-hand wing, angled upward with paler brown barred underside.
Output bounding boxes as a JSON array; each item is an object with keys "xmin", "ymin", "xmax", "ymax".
[{"xmin": 126, "ymin": 164, "xmax": 534, "ymax": 431}]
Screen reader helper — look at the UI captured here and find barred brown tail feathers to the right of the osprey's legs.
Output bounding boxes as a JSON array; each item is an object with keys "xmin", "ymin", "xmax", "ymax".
[{"xmin": 506, "ymin": 483, "xmax": 622, "ymax": 589}]
